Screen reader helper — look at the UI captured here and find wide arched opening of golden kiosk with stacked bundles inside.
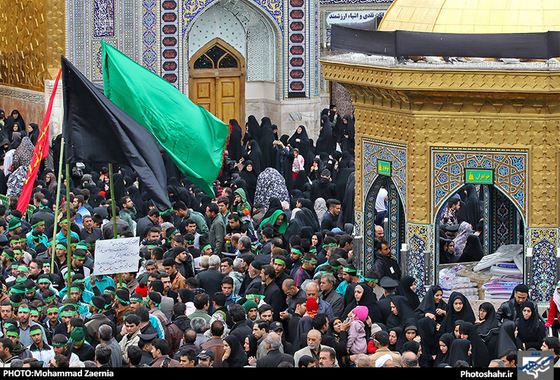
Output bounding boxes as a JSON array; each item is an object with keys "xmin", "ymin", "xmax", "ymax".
[{"xmin": 434, "ymin": 184, "xmax": 525, "ymax": 302}]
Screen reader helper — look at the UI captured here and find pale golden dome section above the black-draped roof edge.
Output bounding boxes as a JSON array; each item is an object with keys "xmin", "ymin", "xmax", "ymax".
[{"xmin": 379, "ymin": 0, "xmax": 560, "ymax": 33}]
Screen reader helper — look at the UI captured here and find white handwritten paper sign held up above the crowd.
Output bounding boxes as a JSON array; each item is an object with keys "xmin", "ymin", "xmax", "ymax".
[{"xmin": 93, "ymin": 237, "xmax": 140, "ymax": 275}]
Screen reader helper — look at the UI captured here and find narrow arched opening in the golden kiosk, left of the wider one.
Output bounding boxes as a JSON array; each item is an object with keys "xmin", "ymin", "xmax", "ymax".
[{"xmin": 364, "ymin": 175, "xmax": 405, "ymax": 272}]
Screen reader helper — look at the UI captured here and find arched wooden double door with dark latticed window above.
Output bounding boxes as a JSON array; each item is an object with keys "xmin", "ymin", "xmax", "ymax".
[{"xmin": 189, "ymin": 38, "xmax": 245, "ymax": 123}]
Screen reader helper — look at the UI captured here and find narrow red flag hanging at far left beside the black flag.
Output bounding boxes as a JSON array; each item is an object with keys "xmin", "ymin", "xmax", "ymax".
[{"xmin": 17, "ymin": 69, "xmax": 62, "ymax": 215}]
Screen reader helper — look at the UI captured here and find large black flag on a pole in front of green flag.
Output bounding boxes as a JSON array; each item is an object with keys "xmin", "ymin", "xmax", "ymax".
[{"xmin": 61, "ymin": 57, "xmax": 171, "ymax": 211}]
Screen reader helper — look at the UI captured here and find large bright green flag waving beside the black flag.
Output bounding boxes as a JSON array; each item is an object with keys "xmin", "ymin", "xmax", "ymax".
[{"xmin": 102, "ymin": 41, "xmax": 230, "ymax": 196}]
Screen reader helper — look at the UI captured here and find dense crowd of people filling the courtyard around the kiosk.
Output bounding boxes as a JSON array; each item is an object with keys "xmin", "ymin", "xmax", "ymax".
[{"xmin": 0, "ymin": 107, "xmax": 560, "ymax": 368}]
